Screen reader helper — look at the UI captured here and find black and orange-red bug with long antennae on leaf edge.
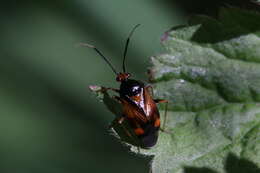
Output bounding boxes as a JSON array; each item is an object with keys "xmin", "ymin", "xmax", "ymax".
[{"xmin": 81, "ymin": 24, "xmax": 168, "ymax": 149}]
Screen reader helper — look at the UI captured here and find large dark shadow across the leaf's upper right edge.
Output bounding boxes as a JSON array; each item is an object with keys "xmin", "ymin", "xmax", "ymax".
[{"xmin": 189, "ymin": 8, "xmax": 260, "ymax": 43}]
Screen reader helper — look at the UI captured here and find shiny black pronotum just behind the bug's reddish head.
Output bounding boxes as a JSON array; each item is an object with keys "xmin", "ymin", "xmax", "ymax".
[{"xmin": 120, "ymin": 79, "xmax": 144, "ymax": 97}]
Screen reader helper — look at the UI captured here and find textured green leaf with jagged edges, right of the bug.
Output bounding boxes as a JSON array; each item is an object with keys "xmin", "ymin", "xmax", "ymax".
[{"xmin": 90, "ymin": 9, "xmax": 260, "ymax": 173}]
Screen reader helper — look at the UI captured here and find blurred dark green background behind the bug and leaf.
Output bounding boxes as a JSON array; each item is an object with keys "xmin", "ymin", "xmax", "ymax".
[{"xmin": 0, "ymin": 0, "xmax": 258, "ymax": 173}]
